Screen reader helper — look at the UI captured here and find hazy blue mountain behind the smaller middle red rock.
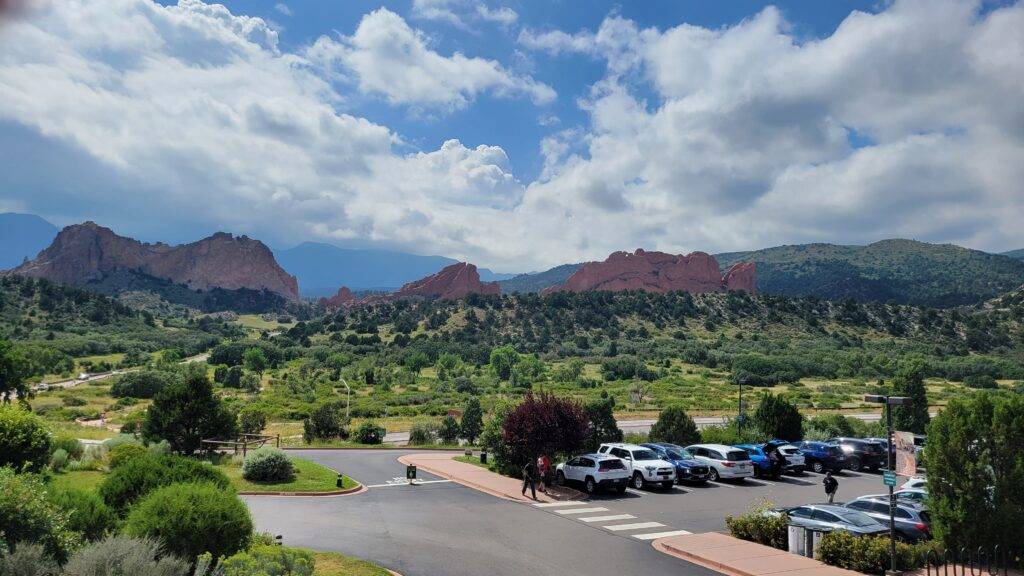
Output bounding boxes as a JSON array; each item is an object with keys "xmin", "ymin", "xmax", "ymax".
[{"xmin": 273, "ymin": 242, "xmax": 512, "ymax": 297}]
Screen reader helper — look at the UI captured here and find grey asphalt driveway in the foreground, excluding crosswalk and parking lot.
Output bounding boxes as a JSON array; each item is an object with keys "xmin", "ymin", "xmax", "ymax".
[{"xmin": 245, "ymin": 450, "xmax": 717, "ymax": 576}]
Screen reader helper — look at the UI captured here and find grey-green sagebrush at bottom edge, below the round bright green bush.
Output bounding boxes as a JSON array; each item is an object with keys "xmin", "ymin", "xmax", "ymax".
[{"xmin": 65, "ymin": 536, "xmax": 191, "ymax": 576}]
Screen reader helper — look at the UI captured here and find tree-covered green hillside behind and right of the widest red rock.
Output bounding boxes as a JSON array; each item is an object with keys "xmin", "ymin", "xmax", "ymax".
[{"xmin": 716, "ymin": 240, "xmax": 1024, "ymax": 306}]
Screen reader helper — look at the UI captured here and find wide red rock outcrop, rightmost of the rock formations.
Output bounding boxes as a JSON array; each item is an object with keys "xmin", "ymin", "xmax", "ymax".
[{"xmin": 542, "ymin": 249, "xmax": 756, "ymax": 293}]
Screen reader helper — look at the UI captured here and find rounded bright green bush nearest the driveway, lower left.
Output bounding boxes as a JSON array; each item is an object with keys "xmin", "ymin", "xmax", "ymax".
[{"xmin": 125, "ymin": 484, "xmax": 253, "ymax": 561}]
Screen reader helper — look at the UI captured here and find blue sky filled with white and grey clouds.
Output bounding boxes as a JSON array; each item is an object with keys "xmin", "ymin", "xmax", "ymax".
[{"xmin": 0, "ymin": 0, "xmax": 1024, "ymax": 272}]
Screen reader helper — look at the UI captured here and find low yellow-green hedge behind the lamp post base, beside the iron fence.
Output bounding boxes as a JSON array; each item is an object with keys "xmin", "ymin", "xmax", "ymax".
[{"xmin": 817, "ymin": 530, "xmax": 935, "ymax": 574}]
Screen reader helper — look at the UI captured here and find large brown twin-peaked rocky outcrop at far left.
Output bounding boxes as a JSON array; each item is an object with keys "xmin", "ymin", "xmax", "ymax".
[{"xmin": 7, "ymin": 221, "xmax": 299, "ymax": 300}]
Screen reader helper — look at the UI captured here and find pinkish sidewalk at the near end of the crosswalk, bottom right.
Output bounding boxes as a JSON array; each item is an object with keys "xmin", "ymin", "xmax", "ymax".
[{"xmin": 653, "ymin": 532, "xmax": 863, "ymax": 576}]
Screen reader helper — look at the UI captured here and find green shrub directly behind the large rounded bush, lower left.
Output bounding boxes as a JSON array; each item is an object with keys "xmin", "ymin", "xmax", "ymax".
[{"xmin": 99, "ymin": 455, "xmax": 230, "ymax": 511}]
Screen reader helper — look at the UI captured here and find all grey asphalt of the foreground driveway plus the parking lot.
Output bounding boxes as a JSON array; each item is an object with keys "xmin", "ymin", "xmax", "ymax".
[{"xmin": 246, "ymin": 450, "xmax": 897, "ymax": 576}]
